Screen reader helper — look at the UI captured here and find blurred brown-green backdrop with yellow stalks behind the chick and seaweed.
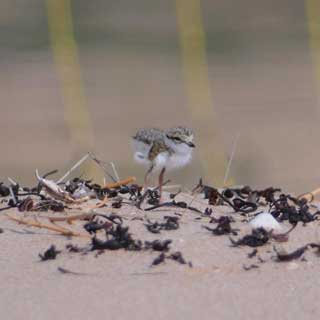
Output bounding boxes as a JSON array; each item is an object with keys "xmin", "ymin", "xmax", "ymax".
[{"xmin": 0, "ymin": 0, "xmax": 320, "ymax": 193}]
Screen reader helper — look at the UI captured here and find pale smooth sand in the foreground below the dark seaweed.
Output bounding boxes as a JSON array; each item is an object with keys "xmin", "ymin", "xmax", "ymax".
[{"xmin": 0, "ymin": 192, "xmax": 320, "ymax": 319}]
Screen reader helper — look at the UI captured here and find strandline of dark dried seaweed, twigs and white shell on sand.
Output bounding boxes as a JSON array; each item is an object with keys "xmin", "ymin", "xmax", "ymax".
[{"xmin": 0, "ymin": 153, "xmax": 320, "ymax": 274}]
